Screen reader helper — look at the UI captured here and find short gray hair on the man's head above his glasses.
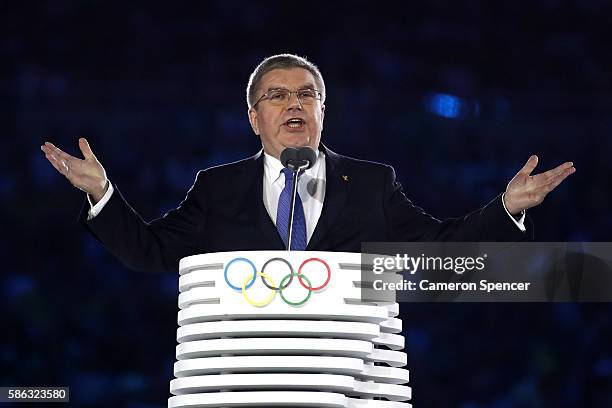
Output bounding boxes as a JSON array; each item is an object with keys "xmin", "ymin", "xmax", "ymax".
[{"xmin": 247, "ymin": 54, "xmax": 325, "ymax": 109}]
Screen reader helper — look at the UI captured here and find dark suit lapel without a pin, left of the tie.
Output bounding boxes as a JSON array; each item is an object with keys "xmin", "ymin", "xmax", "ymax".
[{"xmin": 245, "ymin": 150, "xmax": 285, "ymax": 249}]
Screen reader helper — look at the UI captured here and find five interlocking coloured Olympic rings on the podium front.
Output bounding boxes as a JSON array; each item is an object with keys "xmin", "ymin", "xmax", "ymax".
[{"xmin": 223, "ymin": 258, "xmax": 331, "ymax": 307}]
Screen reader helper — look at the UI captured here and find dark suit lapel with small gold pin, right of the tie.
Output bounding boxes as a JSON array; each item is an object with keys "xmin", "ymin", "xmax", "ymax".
[{"xmin": 306, "ymin": 144, "xmax": 350, "ymax": 250}]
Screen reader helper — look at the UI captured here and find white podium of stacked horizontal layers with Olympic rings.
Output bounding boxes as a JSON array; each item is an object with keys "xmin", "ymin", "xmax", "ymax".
[{"xmin": 168, "ymin": 251, "xmax": 411, "ymax": 408}]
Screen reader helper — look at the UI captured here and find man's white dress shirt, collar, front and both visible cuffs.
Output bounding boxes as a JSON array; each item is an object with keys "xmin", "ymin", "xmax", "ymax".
[{"xmin": 87, "ymin": 150, "xmax": 526, "ymax": 234}]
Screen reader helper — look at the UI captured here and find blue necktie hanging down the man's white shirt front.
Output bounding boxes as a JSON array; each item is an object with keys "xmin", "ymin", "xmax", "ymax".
[{"xmin": 276, "ymin": 169, "xmax": 306, "ymax": 251}]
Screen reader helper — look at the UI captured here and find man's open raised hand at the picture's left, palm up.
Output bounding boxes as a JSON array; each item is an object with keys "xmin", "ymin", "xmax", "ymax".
[{"xmin": 40, "ymin": 138, "xmax": 109, "ymax": 204}]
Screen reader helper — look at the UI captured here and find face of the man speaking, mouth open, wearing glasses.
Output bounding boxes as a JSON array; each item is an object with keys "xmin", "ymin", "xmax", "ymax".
[{"xmin": 249, "ymin": 68, "xmax": 325, "ymax": 158}]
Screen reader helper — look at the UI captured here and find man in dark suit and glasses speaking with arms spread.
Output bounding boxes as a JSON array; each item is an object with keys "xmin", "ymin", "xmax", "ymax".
[{"xmin": 41, "ymin": 54, "xmax": 575, "ymax": 270}]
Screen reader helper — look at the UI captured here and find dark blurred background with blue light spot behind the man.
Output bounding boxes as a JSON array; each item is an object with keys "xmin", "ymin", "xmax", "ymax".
[{"xmin": 0, "ymin": 0, "xmax": 612, "ymax": 408}]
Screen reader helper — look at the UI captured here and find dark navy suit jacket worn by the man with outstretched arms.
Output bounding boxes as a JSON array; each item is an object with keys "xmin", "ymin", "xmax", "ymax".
[{"xmin": 79, "ymin": 145, "xmax": 533, "ymax": 271}]
